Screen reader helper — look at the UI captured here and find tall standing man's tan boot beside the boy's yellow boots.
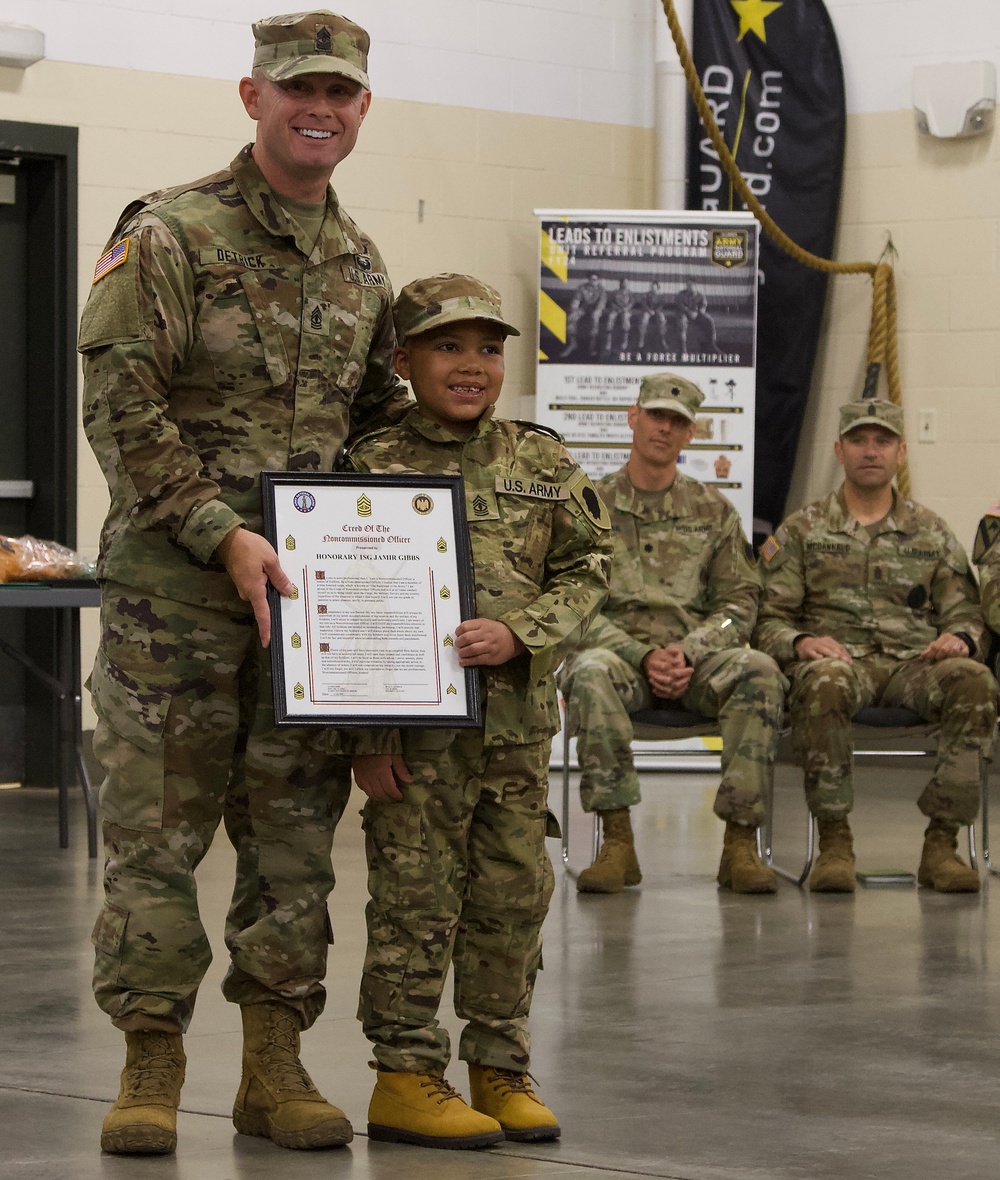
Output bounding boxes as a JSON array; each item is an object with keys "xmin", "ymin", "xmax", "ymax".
[{"xmin": 233, "ymin": 1004, "xmax": 354, "ymax": 1149}]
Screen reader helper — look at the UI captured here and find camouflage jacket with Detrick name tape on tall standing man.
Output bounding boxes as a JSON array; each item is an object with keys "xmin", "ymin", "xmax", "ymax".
[{"xmin": 79, "ymin": 148, "xmax": 409, "ymax": 612}]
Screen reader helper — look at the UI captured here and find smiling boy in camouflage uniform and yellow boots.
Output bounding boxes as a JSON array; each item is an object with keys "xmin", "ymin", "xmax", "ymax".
[{"xmin": 349, "ymin": 275, "xmax": 610, "ymax": 1147}]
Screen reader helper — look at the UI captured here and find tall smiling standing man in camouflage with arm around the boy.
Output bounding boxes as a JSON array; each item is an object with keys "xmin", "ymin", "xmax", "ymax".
[{"xmin": 79, "ymin": 12, "xmax": 407, "ymax": 1153}]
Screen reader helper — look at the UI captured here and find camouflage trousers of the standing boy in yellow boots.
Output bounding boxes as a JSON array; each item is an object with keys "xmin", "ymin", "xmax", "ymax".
[{"xmin": 358, "ymin": 730, "xmax": 557, "ymax": 1073}]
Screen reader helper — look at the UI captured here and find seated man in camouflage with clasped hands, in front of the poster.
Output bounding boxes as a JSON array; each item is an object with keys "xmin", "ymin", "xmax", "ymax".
[{"xmin": 560, "ymin": 373, "xmax": 785, "ymax": 893}]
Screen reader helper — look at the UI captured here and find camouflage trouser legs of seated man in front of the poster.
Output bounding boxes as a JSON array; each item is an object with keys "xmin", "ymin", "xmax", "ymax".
[{"xmin": 558, "ymin": 648, "xmax": 785, "ymax": 827}]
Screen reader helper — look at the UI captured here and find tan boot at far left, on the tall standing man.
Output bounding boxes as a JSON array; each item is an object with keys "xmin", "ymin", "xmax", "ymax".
[{"xmin": 100, "ymin": 1030, "xmax": 187, "ymax": 1155}]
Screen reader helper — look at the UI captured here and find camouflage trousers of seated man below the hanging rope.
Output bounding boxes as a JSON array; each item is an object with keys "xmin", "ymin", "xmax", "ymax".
[{"xmin": 787, "ymin": 655, "xmax": 996, "ymax": 824}]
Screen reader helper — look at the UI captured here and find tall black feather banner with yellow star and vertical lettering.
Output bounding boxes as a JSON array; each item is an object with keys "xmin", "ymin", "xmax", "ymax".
[{"xmin": 687, "ymin": 0, "xmax": 845, "ymax": 535}]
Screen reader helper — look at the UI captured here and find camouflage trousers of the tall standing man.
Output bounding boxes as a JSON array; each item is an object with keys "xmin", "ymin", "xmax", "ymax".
[{"xmin": 90, "ymin": 585, "xmax": 351, "ymax": 1033}]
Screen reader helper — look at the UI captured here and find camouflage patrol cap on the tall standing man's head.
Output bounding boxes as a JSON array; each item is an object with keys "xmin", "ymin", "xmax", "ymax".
[{"xmin": 253, "ymin": 8, "xmax": 372, "ymax": 90}]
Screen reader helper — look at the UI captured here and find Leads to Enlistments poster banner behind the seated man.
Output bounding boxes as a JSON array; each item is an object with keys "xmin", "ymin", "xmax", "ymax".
[{"xmin": 536, "ymin": 210, "xmax": 758, "ymax": 535}]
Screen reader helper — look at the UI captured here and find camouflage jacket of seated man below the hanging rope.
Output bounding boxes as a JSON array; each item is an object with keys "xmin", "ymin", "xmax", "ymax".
[{"xmin": 753, "ymin": 489, "xmax": 983, "ymax": 668}]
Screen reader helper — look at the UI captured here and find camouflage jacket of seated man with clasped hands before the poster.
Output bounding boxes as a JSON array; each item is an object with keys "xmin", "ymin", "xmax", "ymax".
[{"xmin": 583, "ymin": 467, "xmax": 760, "ymax": 669}]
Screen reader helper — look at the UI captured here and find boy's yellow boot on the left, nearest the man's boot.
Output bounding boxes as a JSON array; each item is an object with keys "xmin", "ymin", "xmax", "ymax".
[{"xmin": 368, "ymin": 1067, "xmax": 503, "ymax": 1147}]
